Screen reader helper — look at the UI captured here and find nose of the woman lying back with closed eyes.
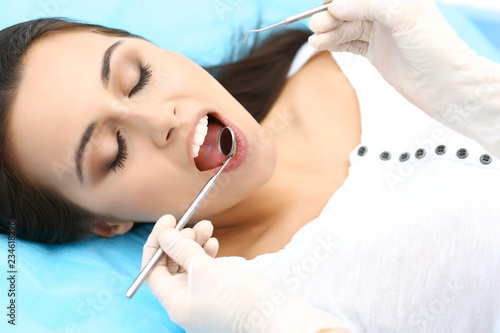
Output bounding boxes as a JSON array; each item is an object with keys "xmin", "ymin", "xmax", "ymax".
[{"xmin": 127, "ymin": 104, "xmax": 180, "ymax": 147}]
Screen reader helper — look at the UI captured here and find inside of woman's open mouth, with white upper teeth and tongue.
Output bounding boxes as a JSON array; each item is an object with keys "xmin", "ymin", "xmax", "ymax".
[{"xmin": 193, "ymin": 114, "xmax": 235, "ymax": 171}]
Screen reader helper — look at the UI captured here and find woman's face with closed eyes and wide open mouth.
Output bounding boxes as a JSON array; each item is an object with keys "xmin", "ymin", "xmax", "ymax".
[{"xmin": 10, "ymin": 31, "xmax": 276, "ymax": 221}]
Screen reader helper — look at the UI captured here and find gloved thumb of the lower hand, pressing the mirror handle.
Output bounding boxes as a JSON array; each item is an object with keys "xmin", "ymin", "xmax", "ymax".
[{"xmin": 158, "ymin": 229, "xmax": 211, "ymax": 272}]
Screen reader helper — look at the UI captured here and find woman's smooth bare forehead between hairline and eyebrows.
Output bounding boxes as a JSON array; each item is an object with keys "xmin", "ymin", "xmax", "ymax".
[{"xmin": 9, "ymin": 32, "xmax": 119, "ymax": 182}]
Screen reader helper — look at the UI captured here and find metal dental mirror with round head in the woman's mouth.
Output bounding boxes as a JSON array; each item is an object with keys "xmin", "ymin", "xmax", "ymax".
[{"xmin": 126, "ymin": 127, "xmax": 236, "ymax": 298}]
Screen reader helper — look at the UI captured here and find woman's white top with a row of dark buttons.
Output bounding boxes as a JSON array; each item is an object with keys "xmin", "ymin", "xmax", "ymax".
[{"xmin": 218, "ymin": 44, "xmax": 500, "ymax": 333}]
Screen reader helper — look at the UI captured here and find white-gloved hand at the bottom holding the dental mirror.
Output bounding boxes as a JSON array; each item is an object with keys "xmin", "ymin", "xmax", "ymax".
[{"xmin": 142, "ymin": 215, "xmax": 349, "ymax": 333}]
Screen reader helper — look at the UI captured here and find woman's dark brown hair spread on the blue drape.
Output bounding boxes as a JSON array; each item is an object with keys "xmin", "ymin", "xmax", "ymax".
[{"xmin": 0, "ymin": 18, "xmax": 309, "ymax": 244}]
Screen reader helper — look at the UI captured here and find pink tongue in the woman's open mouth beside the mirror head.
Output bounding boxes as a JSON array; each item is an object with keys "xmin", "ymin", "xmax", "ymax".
[{"xmin": 194, "ymin": 121, "xmax": 226, "ymax": 171}]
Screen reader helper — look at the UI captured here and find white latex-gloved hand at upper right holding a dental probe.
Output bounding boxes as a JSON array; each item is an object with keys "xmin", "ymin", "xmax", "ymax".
[{"xmin": 309, "ymin": 0, "xmax": 500, "ymax": 157}]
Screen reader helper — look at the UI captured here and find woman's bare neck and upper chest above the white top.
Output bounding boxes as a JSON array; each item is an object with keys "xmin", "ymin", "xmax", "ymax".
[{"xmin": 212, "ymin": 53, "xmax": 361, "ymax": 259}]
